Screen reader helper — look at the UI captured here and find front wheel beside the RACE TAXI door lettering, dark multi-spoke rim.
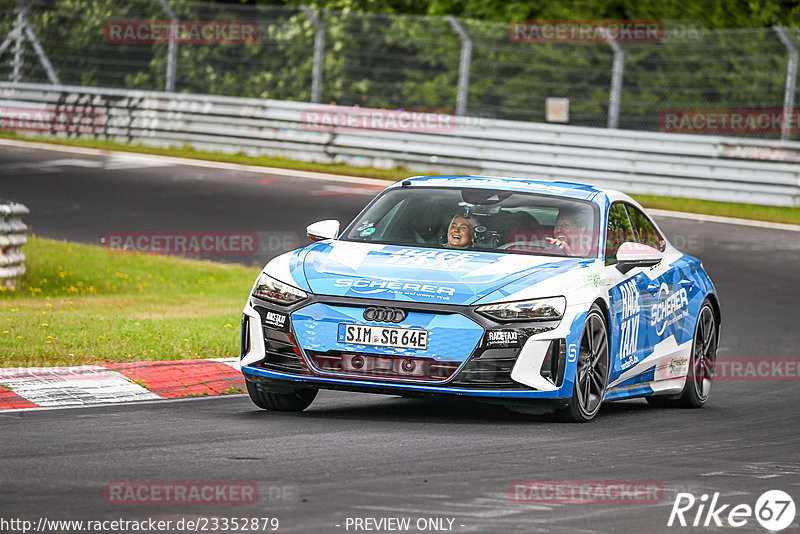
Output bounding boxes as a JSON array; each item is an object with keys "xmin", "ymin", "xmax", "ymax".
[{"xmin": 557, "ymin": 304, "xmax": 610, "ymax": 423}]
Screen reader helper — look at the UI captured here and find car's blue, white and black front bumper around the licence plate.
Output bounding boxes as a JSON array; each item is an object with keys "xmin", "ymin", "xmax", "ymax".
[{"xmin": 240, "ymin": 296, "xmax": 574, "ymax": 404}]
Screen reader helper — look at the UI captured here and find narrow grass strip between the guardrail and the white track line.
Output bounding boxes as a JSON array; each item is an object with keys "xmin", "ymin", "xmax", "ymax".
[{"xmin": 0, "ymin": 132, "xmax": 800, "ymax": 225}]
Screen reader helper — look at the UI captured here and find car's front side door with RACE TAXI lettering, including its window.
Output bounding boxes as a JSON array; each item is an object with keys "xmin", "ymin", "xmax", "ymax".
[{"xmin": 604, "ymin": 202, "xmax": 652, "ymax": 385}]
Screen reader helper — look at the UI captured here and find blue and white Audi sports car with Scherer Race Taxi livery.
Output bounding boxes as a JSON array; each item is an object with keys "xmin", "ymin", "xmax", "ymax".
[{"xmin": 240, "ymin": 176, "xmax": 720, "ymax": 422}]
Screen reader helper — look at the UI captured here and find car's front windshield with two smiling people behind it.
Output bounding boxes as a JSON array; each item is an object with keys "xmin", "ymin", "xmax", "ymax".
[{"xmin": 341, "ymin": 187, "xmax": 599, "ymax": 258}]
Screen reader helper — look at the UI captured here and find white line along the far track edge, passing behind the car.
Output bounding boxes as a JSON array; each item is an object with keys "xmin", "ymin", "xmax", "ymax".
[{"xmin": 0, "ymin": 139, "xmax": 800, "ymax": 232}]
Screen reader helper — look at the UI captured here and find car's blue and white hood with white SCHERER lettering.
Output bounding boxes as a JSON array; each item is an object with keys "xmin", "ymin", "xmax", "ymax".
[{"xmin": 295, "ymin": 241, "xmax": 590, "ymax": 305}]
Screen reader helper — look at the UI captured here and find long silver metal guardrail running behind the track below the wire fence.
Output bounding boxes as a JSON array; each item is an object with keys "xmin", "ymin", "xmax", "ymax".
[{"xmin": 0, "ymin": 82, "xmax": 800, "ymax": 206}]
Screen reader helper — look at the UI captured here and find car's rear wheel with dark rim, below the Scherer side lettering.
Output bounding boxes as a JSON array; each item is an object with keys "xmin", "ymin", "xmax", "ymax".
[{"xmin": 647, "ymin": 300, "xmax": 719, "ymax": 408}]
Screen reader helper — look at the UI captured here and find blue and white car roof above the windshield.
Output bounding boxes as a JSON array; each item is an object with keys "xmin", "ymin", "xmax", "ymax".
[{"xmin": 394, "ymin": 174, "xmax": 612, "ymax": 200}]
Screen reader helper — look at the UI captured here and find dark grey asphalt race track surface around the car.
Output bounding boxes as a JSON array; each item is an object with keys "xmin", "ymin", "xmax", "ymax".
[{"xmin": 0, "ymin": 146, "xmax": 800, "ymax": 533}]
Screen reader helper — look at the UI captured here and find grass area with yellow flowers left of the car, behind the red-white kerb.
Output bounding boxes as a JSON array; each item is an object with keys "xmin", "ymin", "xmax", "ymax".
[{"xmin": 0, "ymin": 237, "xmax": 257, "ymax": 367}]
